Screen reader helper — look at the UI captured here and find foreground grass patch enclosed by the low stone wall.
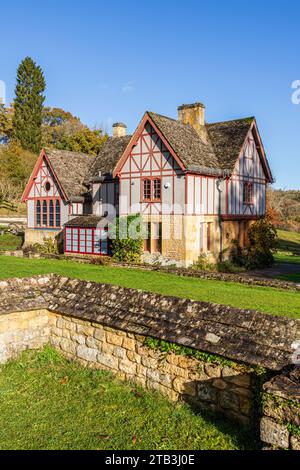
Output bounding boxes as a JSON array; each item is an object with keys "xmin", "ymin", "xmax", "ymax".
[{"xmin": 0, "ymin": 346, "xmax": 256, "ymax": 450}]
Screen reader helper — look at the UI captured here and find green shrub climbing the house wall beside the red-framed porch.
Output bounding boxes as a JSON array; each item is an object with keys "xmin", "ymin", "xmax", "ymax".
[{"xmin": 110, "ymin": 215, "xmax": 144, "ymax": 263}]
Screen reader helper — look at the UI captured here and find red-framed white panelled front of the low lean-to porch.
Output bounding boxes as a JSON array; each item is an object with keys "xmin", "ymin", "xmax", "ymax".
[{"xmin": 64, "ymin": 227, "xmax": 109, "ymax": 256}]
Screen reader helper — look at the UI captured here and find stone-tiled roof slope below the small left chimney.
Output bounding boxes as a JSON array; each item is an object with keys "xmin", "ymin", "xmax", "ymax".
[{"xmin": 86, "ymin": 135, "xmax": 131, "ymax": 182}]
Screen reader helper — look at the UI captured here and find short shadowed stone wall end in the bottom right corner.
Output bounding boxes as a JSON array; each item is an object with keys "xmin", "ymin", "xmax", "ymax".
[{"xmin": 261, "ymin": 366, "xmax": 300, "ymax": 450}]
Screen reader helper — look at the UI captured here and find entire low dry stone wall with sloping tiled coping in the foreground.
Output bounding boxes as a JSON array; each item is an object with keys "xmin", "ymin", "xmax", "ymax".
[{"xmin": 0, "ymin": 275, "xmax": 300, "ymax": 442}]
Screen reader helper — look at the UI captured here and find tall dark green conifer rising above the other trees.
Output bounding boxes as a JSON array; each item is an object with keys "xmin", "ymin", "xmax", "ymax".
[{"xmin": 13, "ymin": 57, "xmax": 46, "ymax": 153}]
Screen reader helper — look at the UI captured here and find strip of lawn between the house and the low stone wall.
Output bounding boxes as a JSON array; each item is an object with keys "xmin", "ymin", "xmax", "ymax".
[{"xmin": 0, "ymin": 257, "xmax": 300, "ymax": 318}]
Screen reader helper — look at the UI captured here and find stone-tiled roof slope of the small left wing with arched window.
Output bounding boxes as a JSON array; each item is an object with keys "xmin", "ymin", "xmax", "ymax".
[{"xmin": 45, "ymin": 149, "xmax": 96, "ymax": 200}]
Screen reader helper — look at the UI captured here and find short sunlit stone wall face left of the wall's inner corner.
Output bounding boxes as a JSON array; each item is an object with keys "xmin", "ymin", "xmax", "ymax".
[{"xmin": 0, "ymin": 309, "xmax": 50, "ymax": 364}]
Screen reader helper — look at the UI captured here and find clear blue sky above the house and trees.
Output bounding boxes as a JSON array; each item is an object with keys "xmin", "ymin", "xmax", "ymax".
[{"xmin": 0, "ymin": 0, "xmax": 300, "ymax": 189}]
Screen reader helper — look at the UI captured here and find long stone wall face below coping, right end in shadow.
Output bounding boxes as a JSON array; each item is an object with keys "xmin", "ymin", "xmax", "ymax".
[{"xmin": 50, "ymin": 314, "xmax": 255, "ymax": 425}]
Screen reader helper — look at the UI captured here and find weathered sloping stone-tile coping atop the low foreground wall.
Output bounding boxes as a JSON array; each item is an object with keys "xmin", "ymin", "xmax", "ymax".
[{"xmin": 0, "ymin": 274, "xmax": 300, "ymax": 371}]
